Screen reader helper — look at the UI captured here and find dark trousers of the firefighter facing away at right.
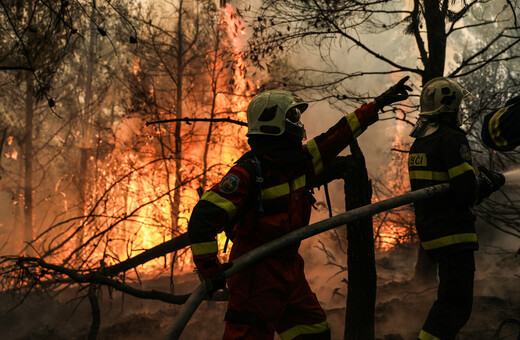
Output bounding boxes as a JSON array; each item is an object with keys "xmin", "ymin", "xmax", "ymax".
[{"xmin": 419, "ymin": 250, "xmax": 475, "ymax": 340}]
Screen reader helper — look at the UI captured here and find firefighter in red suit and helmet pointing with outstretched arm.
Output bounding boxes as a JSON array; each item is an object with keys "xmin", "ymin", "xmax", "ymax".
[{"xmin": 188, "ymin": 77, "xmax": 411, "ymax": 340}]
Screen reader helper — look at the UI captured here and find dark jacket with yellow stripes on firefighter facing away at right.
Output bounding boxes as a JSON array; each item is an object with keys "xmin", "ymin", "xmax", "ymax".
[{"xmin": 408, "ymin": 123, "xmax": 478, "ymax": 260}]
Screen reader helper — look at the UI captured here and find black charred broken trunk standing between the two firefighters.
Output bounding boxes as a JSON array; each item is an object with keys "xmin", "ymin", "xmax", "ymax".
[{"xmin": 344, "ymin": 141, "xmax": 376, "ymax": 340}]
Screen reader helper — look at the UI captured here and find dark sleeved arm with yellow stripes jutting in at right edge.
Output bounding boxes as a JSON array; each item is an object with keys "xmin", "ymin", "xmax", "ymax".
[{"xmin": 481, "ymin": 96, "xmax": 520, "ymax": 151}]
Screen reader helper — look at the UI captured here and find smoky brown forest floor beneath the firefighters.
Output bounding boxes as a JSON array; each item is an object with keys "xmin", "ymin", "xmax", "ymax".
[{"xmin": 0, "ymin": 238, "xmax": 520, "ymax": 340}]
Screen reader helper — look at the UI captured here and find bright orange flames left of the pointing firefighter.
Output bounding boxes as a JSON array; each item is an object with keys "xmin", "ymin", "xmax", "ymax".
[{"xmin": 58, "ymin": 4, "xmax": 253, "ymax": 275}]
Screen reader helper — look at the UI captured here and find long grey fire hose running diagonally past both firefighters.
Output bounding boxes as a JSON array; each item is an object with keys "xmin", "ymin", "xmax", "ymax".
[{"xmin": 165, "ymin": 183, "xmax": 449, "ymax": 340}]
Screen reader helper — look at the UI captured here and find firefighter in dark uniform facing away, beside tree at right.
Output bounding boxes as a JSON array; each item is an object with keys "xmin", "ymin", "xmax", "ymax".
[{"xmin": 408, "ymin": 77, "xmax": 505, "ymax": 340}]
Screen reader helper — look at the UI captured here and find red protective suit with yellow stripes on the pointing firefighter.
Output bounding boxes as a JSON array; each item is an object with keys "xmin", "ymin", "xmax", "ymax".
[{"xmin": 188, "ymin": 103, "xmax": 378, "ymax": 339}]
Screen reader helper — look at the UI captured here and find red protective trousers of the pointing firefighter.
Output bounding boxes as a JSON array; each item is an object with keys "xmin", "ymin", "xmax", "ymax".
[{"xmin": 224, "ymin": 248, "xmax": 328, "ymax": 340}]
